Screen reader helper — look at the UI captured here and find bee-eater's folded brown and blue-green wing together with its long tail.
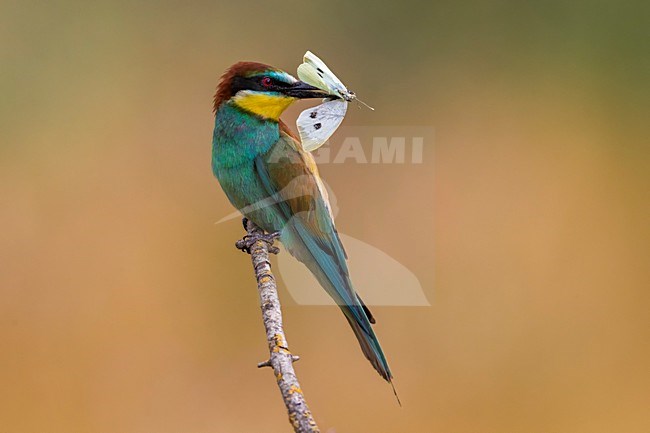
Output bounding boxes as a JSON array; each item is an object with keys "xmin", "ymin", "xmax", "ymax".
[{"xmin": 255, "ymin": 134, "xmax": 392, "ymax": 382}]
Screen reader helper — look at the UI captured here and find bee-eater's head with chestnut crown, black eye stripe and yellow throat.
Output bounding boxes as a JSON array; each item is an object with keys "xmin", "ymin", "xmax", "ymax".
[{"xmin": 214, "ymin": 62, "xmax": 327, "ymax": 121}]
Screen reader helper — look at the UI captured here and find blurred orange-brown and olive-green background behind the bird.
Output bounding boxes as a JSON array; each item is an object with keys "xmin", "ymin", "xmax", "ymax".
[{"xmin": 0, "ymin": 0, "xmax": 650, "ymax": 433}]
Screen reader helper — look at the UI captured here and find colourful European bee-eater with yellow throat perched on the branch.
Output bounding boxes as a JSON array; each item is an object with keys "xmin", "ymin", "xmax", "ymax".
[{"xmin": 212, "ymin": 62, "xmax": 392, "ymax": 383}]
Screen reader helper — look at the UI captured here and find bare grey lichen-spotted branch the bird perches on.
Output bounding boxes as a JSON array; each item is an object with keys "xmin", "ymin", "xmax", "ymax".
[{"xmin": 236, "ymin": 219, "xmax": 320, "ymax": 433}]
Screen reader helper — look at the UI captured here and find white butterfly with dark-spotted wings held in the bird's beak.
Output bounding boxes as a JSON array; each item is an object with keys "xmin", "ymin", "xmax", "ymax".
[{"xmin": 296, "ymin": 51, "xmax": 374, "ymax": 152}]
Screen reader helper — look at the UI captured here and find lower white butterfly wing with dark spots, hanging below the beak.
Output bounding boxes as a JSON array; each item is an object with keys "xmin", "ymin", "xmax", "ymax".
[{"xmin": 296, "ymin": 99, "xmax": 348, "ymax": 152}]
